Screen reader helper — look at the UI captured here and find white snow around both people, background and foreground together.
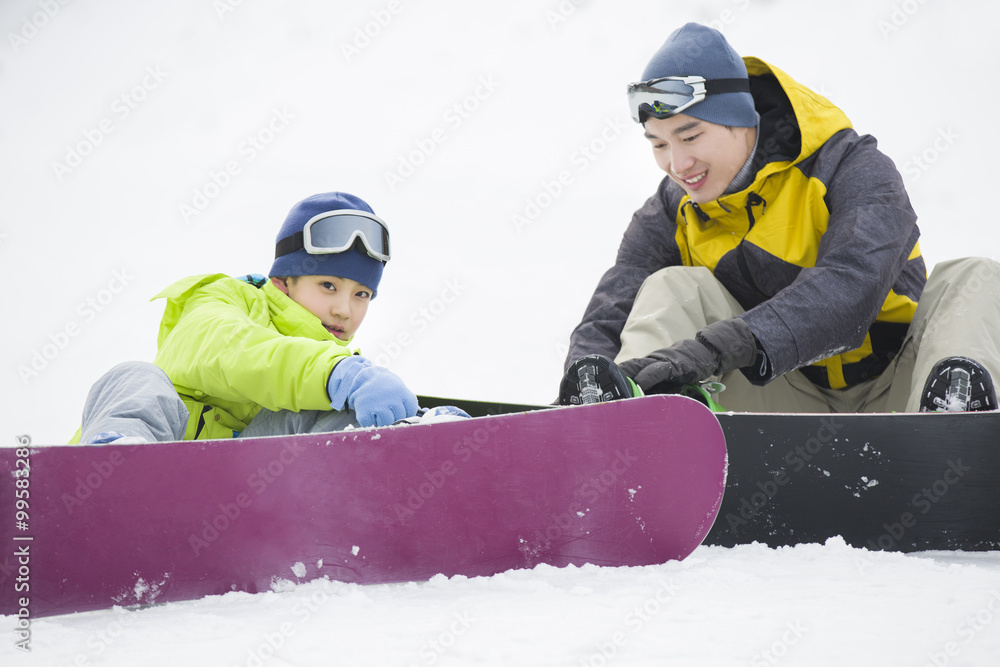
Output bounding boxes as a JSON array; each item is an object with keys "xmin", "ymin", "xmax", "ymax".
[{"xmin": 0, "ymin": 0, "xmax": 1000, "ymax": 667}]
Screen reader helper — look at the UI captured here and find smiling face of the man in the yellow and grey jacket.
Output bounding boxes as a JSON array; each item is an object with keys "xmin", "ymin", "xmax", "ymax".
[{"xmin": 644, "ymin": 114, "xmax": 757, "ymax": 204}]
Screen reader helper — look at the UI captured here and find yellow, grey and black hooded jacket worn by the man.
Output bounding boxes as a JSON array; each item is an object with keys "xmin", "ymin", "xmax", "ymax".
[{"xmin": 567, "ymin": 58, "xmax": 927, "ymax": 389}]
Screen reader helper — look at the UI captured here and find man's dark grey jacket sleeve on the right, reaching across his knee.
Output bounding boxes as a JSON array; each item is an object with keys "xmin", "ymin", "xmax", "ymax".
[{"xmin": 741, "ymin": 130, "xmax": 923, "ymax": 384}]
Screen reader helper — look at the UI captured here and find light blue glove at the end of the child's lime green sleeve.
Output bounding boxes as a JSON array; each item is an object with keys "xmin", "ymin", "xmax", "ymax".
[{"xmin": 326, "ymin": 356, "xmax": 419, "ymax": 427}]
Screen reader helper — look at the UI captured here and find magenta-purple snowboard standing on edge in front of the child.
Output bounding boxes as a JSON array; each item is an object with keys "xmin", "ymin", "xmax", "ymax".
[{"xmin": 0, "ymin": 396, "xmax": 726, "ymax": 617}]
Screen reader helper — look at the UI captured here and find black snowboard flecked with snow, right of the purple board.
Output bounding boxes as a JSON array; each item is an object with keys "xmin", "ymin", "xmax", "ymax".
[{"xmin": 706, "ymin": 412, "xmax": 1000, "ymax": 551}]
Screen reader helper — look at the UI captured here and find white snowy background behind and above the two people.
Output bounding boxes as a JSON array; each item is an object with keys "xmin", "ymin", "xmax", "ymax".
[{"xmin": 0, "ymin": 0, "xmax": 1000, "ymax": 445}]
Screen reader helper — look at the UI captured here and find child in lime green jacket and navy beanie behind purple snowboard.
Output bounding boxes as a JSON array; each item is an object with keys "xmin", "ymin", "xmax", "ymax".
[{"xmin": 73, "ymin": 192, "xmax": 418, "ymax": 444}]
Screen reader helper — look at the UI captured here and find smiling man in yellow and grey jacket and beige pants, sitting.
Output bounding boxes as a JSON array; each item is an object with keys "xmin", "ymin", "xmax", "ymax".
[{"xmin": 560, "ymin": 23, "xmax": 1000, "ymax": 412}]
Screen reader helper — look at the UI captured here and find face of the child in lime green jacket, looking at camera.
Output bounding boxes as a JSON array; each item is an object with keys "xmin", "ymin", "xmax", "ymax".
[{"xmin": 271, "ymin": 276, "xmax": 372, "ymax": 340}]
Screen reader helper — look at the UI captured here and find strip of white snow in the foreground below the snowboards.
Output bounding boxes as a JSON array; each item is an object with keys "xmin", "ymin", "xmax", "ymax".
[{"xmin": 0, "ymin": 539, "xmax": 1000, "ymax": 667}]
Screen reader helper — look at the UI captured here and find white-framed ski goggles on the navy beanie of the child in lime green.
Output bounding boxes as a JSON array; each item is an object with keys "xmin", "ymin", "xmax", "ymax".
[{"xmin": 274, "ymin": 211, "xmax": 389, "ymax": 262}]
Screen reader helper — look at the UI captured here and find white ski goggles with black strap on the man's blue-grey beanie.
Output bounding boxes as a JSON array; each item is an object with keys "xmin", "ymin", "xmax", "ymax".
[{"xmin": 628, "ymin": 76, "xmax": 750, "ymax": 123}]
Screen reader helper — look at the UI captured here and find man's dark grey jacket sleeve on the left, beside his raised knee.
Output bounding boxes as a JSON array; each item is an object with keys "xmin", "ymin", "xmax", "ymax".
[{"xmin": 564, "ymin": 178, "xmax": 681, "ymax": 367}]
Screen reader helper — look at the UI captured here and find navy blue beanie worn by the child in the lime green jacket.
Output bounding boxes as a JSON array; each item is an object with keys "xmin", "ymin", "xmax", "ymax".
[{"xmin": 268, "ymin": 192, "xmax": 385, "ymax": 298}]
